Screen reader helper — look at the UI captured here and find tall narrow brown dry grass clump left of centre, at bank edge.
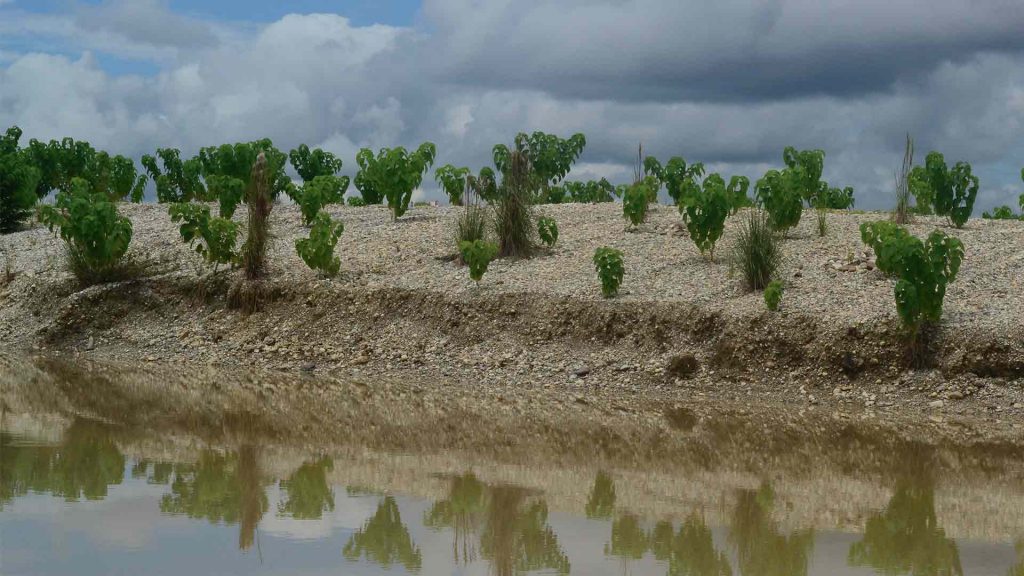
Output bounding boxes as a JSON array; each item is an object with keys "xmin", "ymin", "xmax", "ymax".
[{"xmin": 227, "ymin": 153, "xmax": 273, "ymax": 314}]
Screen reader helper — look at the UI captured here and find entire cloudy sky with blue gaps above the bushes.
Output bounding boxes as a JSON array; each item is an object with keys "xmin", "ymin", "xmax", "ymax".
[{"xmin": 0, "ymin": 0, "xmax": 1024, "ymax": 206}]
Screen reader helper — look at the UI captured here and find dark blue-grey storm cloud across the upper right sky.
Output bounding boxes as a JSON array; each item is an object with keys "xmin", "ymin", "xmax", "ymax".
[{"xmin": 424, "ymin": 0, "xmax": 1024, "ymax": 101}]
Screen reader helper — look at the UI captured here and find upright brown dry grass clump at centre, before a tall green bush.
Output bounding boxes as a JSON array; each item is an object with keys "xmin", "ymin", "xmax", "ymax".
[{"xmin": 495, "ymin": 150, "xmax": 536, "ymax": 257}]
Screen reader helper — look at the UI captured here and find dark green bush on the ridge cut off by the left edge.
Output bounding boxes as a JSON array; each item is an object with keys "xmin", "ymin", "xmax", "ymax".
[{"xmin": 0, "ymin": 126, "xmax": 41, "ymax": 234}]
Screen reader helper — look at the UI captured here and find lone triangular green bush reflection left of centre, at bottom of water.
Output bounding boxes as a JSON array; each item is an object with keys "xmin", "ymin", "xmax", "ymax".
[{"xmin": 342, "ymin": 496, "xmax": 423, "ymax": 572}]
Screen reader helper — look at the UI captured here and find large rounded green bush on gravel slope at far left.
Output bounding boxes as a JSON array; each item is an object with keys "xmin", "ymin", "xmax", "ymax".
[{"xmin": 39, "ymin": 178, "xmax": 132, "ymax": 283}]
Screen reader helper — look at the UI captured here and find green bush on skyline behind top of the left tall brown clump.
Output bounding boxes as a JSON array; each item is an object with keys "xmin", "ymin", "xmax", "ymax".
[{"xmin": 199, "ymin": 138, "xmax": 292, "ymax": 218}]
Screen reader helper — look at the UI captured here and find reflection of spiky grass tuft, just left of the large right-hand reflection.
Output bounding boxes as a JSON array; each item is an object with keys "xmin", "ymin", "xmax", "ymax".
[{"xmin": 729, "ymin": 483, "xmax": 814, "ymax": 576}]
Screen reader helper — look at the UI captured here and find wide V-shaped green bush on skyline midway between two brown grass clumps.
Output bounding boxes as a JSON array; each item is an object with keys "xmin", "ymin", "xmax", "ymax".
[{"xmin": 355, "ymin": 142, "xmax": 437, "ymax": 219}]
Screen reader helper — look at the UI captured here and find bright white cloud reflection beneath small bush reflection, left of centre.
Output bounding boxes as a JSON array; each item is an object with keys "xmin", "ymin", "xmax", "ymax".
[{"xmin": 259, "ymin": 486, "xmax": 377, "ymax": 540}]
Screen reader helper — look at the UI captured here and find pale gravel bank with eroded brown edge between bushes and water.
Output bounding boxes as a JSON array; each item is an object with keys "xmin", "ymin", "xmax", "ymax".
[{"xmin": 0, "ymin": 204, "xmax": 1024, "ymax": 444}]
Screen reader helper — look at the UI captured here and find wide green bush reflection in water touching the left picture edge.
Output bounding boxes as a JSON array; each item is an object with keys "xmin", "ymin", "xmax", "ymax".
[{"xmin": 0, "ymin": 420, "xmax": 125, "ymax": 508}]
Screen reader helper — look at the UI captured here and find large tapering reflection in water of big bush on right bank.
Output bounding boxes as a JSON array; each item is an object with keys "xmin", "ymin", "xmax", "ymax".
[{"xmin": 849, "ymin": 471, "xmax": 964, "ymax": 576}]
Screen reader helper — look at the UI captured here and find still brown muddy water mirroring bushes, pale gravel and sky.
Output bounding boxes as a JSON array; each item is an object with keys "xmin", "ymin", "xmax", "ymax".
[{"xmin": 0, "ymin": 358, "xmax": 1024, "ymax": 576}]
